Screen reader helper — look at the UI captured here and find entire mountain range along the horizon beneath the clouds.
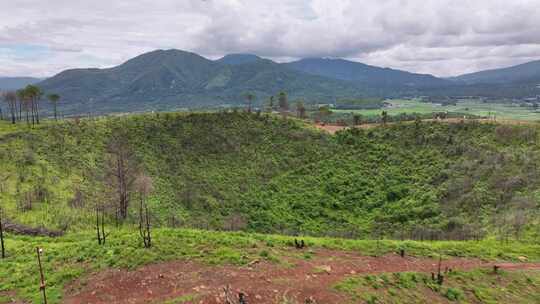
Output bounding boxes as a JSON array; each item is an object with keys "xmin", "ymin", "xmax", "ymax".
[{"xmin": 5, "ymin": 49, "xmax": 540, "ymax": 112}]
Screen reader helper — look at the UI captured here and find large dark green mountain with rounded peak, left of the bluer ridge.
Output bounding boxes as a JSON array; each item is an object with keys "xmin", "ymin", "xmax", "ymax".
[{"xmin": 39, "ymin": 50, "xmax": 366, "ymax": 112}]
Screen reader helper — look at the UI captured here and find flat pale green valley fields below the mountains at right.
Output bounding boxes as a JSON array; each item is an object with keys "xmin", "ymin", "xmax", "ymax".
[{"xmin": 334, "ymin": 99, "xmax": 540, "ymax": 121}]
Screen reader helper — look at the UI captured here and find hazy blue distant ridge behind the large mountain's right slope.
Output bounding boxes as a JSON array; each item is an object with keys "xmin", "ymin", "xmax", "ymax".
[{"xmin": 285, "ymin": 58, "xmax": 449, "ymax": 90}]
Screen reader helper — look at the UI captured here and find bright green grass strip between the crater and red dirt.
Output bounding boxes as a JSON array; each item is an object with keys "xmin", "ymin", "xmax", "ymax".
[{"xmin": 0, "ymin": 228, "xmax": 540, "ymax": 303}]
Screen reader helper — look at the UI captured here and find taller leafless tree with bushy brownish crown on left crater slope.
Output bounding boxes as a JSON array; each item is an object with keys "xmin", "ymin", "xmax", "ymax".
[{"xmin": 107, "ymin": 131, "xmax": 137, "ymax": 220}]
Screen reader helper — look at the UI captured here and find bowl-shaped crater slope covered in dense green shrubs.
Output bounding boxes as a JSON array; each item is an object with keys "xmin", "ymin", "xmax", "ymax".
[{"xmin": 0, "ymin": 113, "xmax": 540, "ymax": 239}]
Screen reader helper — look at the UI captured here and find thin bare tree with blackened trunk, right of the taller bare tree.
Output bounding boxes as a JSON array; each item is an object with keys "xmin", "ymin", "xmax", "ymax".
[{"xmin": 135, "ymin": 173, "xmax": 154, "ymax": 248}]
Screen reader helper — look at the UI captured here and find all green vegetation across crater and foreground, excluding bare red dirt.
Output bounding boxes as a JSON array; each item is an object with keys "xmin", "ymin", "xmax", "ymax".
[{"xmin": 0, "ymin": 112, "xmax": 540, "ymax": 303}]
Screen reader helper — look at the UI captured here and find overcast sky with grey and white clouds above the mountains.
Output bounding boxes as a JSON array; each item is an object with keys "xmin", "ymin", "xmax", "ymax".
[{"xmin": 0, "ymin": 0, "xmax": 540, "ymax": 77}]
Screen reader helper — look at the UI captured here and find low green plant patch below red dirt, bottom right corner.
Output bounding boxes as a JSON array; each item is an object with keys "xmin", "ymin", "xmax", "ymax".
[{"xmin": 335, "ymin": 269, "xmax": 540, "ymax": 304}]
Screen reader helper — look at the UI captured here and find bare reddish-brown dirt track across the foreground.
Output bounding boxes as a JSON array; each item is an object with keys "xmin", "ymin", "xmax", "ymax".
[{"xmin": 65, "ymin": 250, "xmax": 540, "ymax": 304}]
